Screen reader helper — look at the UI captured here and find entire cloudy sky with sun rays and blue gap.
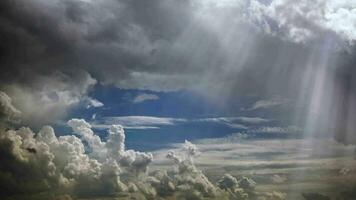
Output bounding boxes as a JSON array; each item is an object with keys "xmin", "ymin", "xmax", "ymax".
[{"xmin": 0, "ymin": 0, "xmax": 356, "ymax": 199}]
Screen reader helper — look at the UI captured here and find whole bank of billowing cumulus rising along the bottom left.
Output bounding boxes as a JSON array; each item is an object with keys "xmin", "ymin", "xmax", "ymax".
[{"xmin": 0, "ymin": 119, "xmax": 294, "ymax": 199}]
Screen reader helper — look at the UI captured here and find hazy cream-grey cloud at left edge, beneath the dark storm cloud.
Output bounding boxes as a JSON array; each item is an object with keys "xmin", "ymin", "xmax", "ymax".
[{"xmin": 1, "ymin": 71, "xmax": 97, "ymax": 127}]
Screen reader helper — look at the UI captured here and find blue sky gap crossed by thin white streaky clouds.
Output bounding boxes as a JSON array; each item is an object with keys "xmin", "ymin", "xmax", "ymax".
[{"xmin": 59, "ymin": 84, "xmax": 302, "ymax": 150}]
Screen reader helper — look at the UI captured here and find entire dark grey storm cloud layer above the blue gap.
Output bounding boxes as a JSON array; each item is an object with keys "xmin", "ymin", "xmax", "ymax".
[{"xmin": 0, "ymin": 0, "xmax": 355, "ymax": 133}]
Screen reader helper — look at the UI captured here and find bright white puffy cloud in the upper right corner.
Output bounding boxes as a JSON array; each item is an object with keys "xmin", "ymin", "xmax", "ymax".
[{"xmin": 264, "ymin": 0, "xmax": 356, "ymax": 42}]
